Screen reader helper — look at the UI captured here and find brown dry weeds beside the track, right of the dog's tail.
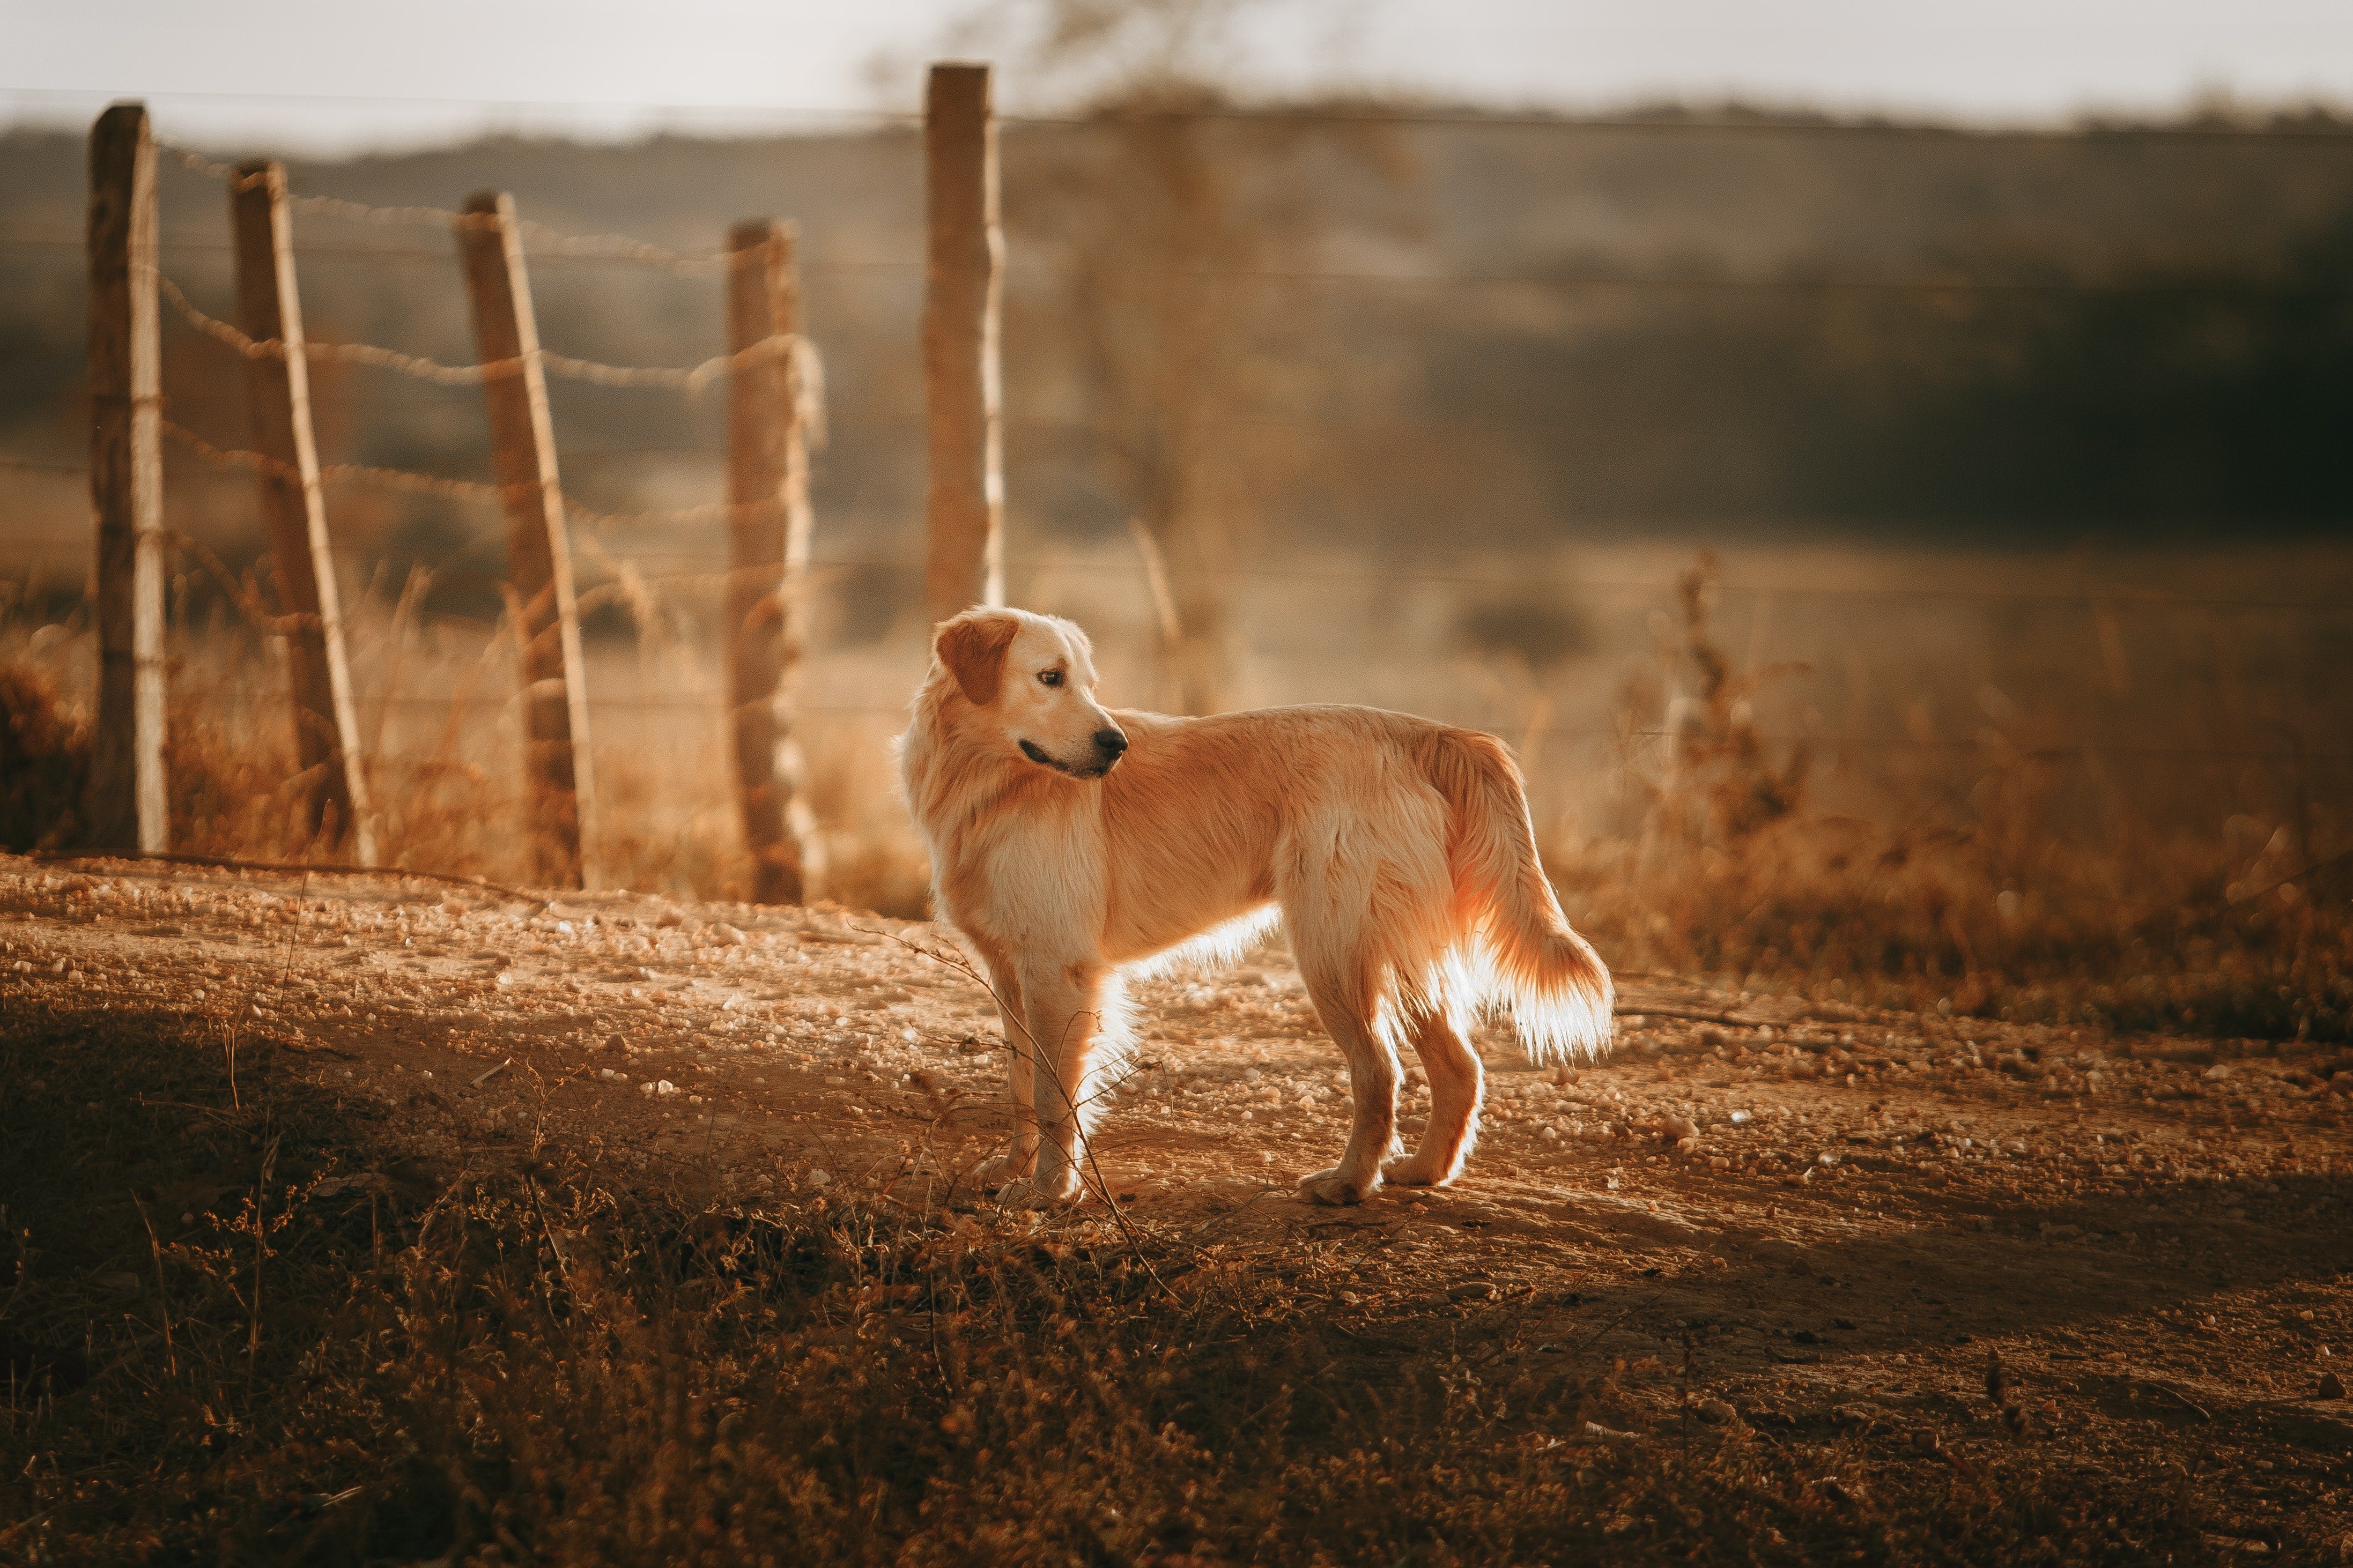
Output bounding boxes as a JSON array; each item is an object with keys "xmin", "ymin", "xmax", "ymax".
[{"xmin": 1548, "ymin": 562, "xmax": 2353, "ymax": 1039}]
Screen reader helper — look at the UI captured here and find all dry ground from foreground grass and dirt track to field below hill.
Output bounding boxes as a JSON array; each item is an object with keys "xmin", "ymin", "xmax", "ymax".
[{"xmin": 0, "ymin": 541, "xmax": 2353, "ymax": 1568}]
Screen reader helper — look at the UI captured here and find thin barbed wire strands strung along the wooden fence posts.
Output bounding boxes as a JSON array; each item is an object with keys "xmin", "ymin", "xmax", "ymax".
[{"xmin": 0, "ymin": 98, "xmax": 2353, "ymax": 893}]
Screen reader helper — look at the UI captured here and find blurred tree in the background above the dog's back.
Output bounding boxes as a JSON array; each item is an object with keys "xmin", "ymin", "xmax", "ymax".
[{"xmin": 965, "ymin": 0, "xmax": 1402, "ymax": 712}]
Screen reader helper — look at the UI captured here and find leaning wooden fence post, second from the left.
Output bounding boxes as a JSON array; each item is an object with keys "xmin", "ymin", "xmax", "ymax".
[{"xmin": 228, "ymin": 158, "xmax": 376, "ymax": 865}]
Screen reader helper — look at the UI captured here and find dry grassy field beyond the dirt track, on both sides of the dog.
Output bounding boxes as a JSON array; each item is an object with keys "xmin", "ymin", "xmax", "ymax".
[{"xmin": 0, "ymin": 545, "xmax": 2353, "ymax": 1039}]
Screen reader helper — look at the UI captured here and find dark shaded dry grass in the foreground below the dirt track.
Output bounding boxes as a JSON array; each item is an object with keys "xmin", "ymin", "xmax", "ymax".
[{"xmin": 0, "ymin": 1008, "xmax": 2240, "ymax": 1566}]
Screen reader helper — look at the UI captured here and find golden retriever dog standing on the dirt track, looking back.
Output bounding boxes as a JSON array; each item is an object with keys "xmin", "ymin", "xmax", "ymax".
[{"xmin": 899, "ymin": 609, "xmax": 1609, "ymax": 1206}]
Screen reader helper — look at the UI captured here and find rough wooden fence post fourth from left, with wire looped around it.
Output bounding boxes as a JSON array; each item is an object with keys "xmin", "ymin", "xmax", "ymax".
[{"xmin": 727, "ymin": 219, "xmax": 824, "ymax": 903}]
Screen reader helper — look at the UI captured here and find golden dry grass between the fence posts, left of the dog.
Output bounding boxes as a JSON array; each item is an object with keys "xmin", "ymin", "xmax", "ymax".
[{"xmin": 0, "ymin": 583, "xmax": 927, "ymax": 915}]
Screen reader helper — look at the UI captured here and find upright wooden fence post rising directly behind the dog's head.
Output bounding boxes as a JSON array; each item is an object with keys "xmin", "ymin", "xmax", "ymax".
[{"xmin": 922, "ymin": 66, "xmax": 1005, "ymax": 621}]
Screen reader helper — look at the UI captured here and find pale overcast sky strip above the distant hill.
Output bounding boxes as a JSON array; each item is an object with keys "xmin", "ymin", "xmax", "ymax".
[{"xmin": 0, "ymin": 0, "xmax": 2353, "ymax": 153}]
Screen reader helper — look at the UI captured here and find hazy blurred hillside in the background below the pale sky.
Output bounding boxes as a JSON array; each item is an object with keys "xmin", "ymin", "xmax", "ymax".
[{"xmin": 0, "ymin": 110, "xmax": 2353, "ymax": 601}]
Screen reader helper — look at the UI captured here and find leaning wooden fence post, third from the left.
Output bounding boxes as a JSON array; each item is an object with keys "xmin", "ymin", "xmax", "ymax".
[{"xmin": 459, "ymin": 190, "xmax": 595, "ymax": 889}]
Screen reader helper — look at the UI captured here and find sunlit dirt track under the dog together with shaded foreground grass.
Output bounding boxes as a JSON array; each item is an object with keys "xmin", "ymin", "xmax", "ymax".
[{"xmin": 0, "ymin": 858, "xmax": 2353, "ymax": 1563}]
